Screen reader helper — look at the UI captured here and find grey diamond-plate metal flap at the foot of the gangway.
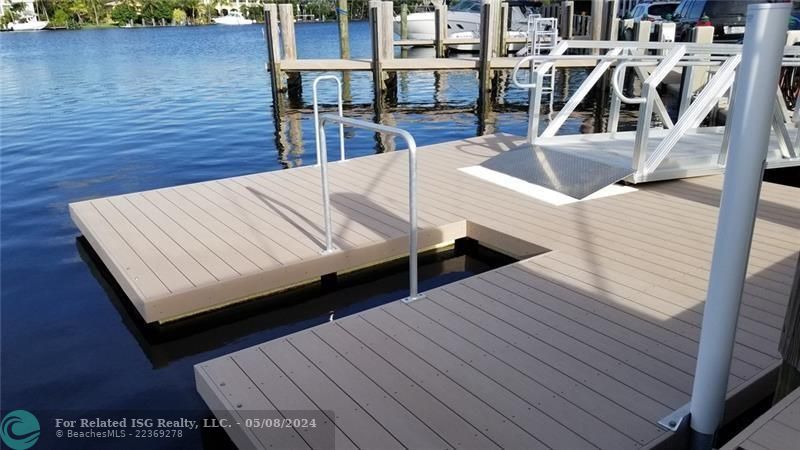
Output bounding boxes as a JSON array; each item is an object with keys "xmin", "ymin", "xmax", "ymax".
[{"xmin": 481, "ymin": 146, "xmax": 634, "ymax": 200}]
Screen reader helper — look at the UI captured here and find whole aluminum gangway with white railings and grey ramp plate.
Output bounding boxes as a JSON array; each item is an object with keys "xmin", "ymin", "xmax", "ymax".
[{"xmin": 483, "ymin": 41, "xmax": 800, "ymax": 198}]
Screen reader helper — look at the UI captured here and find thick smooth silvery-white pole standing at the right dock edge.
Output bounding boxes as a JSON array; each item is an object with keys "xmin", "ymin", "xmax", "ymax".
[{"xmin": 691, "ymin": 3, "xmax": 792, "ymax": 450}]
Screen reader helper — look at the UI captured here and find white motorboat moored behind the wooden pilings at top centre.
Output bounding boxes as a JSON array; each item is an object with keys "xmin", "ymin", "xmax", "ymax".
[{"xmin": 394, "ymin": 0, "xmax": 527, "ymax": 51}]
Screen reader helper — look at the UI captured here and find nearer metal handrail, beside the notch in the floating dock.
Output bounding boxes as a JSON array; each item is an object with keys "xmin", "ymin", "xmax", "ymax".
[{"xmin": 317, "ymin": 114, "xmax": 424, "ymax": 302}]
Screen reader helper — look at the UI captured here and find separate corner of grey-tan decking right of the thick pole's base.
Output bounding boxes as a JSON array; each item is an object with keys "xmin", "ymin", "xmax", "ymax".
[{"xmin": 721, "ymin": 389, "xmax": 800, "ymax": 450}]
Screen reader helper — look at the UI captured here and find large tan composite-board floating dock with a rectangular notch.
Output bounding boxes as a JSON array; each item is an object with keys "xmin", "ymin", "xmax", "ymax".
[{"xmin": 71, "ymin": 136, "xmax": 800, "ymax": 449}]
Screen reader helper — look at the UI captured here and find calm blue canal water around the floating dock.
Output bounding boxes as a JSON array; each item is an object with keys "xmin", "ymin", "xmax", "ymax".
[{"xmin": 0, "ymin": 23, "xmax": 616, "ymax": 448}]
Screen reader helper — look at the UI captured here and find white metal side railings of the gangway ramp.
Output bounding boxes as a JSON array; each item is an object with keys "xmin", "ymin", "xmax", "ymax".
[{"xmin": 512, "ymin": 41, "xmax": 800, "ymax": 181}]
